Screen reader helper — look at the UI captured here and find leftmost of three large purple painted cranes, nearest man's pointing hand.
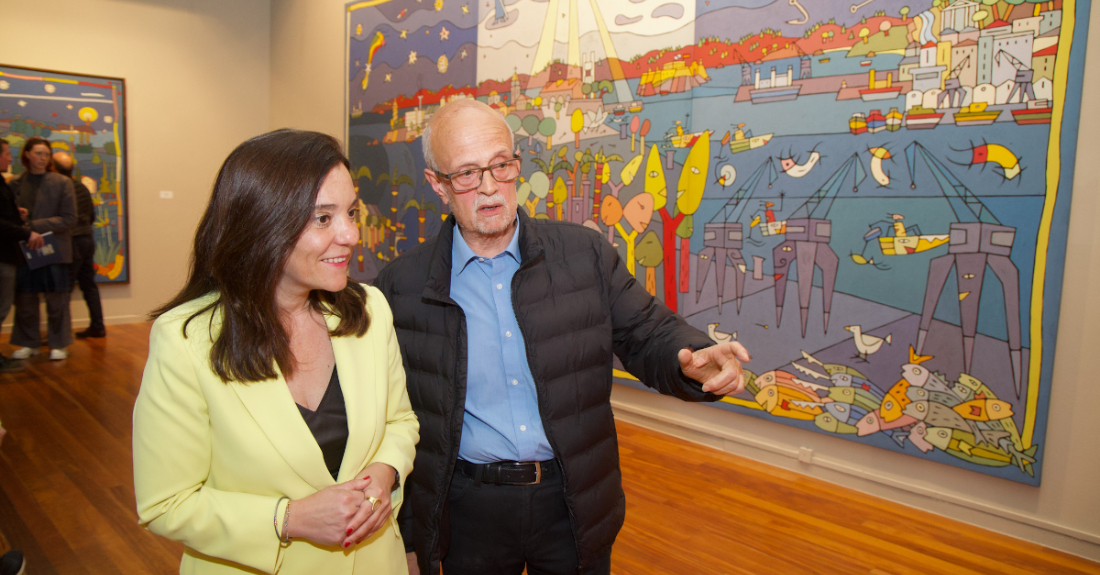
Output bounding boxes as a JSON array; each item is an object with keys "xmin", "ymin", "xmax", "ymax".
[{"xmin": 695, "ymin": 157, "xmax": 779, "ymax": 313}]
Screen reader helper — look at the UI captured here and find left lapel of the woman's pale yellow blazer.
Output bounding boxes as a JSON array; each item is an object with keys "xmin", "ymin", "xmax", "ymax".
[{"xmin": 230, "ymin": 376, "xmax": 336, "ymax": 490}]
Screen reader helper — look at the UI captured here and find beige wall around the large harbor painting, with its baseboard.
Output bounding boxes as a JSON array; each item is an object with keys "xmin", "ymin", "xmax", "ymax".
[{"xmin": 271, "ymin": 0, "xmax": 1100, "ymax": 560}]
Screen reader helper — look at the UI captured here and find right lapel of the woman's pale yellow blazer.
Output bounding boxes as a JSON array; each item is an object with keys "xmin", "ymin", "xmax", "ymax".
[{"xmin": 327, "ymin": 316, "xmax": 385, "ymax": 483}]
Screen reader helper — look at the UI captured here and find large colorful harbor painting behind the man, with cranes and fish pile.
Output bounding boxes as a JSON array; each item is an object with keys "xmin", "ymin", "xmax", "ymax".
[{"xmin": 347, "ymin": 0, "xmax": 1089, "ymax": 485}]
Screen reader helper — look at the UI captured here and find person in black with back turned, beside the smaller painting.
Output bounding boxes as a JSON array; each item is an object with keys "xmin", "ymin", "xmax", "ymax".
[{"xmin": 54, "ymin": 152, "xmax": 107, "ymax": 338}]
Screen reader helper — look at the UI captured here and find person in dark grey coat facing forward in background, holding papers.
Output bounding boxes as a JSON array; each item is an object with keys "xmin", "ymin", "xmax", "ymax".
[{"xmin": 11, "ymin": 137, "xmax": 76, "ymax": 361}]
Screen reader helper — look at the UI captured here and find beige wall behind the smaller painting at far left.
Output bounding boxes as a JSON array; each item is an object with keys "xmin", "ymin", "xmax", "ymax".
[{"xmin": 0, "ymin": 0, "xmax": 271, "ymax": 327}]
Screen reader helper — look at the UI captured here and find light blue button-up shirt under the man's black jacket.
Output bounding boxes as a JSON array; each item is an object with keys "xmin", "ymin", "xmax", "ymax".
[{"xmin": 451, "ymin": 223, "xmax": 553, "ymax": 463}]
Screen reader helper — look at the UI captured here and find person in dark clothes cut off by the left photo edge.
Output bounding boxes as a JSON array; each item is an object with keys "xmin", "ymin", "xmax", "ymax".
[{"xmin": 0, "ymin": 139, "xmax": 42, "ymax": 372}]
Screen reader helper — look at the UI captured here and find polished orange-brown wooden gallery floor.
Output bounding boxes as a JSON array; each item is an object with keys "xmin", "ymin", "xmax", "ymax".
[{"xmin": 0, "ymin": 324, "xmax": 1100, "ymax": 575}]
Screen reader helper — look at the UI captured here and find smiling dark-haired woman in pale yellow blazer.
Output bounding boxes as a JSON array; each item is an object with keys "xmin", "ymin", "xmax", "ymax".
[{"xmin": 133, "ymin": 130, "xmax": 419, "ymax": 574}]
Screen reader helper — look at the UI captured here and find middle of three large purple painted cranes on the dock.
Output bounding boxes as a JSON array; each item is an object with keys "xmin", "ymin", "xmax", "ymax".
[{"xmin": 772, "ymin": 154, "xmax": 867, "ymax": 338}]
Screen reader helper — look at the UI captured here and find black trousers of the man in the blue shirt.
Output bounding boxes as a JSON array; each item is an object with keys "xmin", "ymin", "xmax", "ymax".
[{"xmin": 443, "ymin": 464, "xmax": 612, "ymax": 575}]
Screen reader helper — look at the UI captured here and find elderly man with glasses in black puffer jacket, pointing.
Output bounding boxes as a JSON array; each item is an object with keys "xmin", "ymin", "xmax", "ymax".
[{"xmin": 377, "ymin": 100, "xmax": 749, "ymax": 575}]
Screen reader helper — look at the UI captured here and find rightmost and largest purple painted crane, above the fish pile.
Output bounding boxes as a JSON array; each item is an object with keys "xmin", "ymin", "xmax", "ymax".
[{"xmin": 905, "ymin": 142, "xmax": 1023, "ymax": 397}]
